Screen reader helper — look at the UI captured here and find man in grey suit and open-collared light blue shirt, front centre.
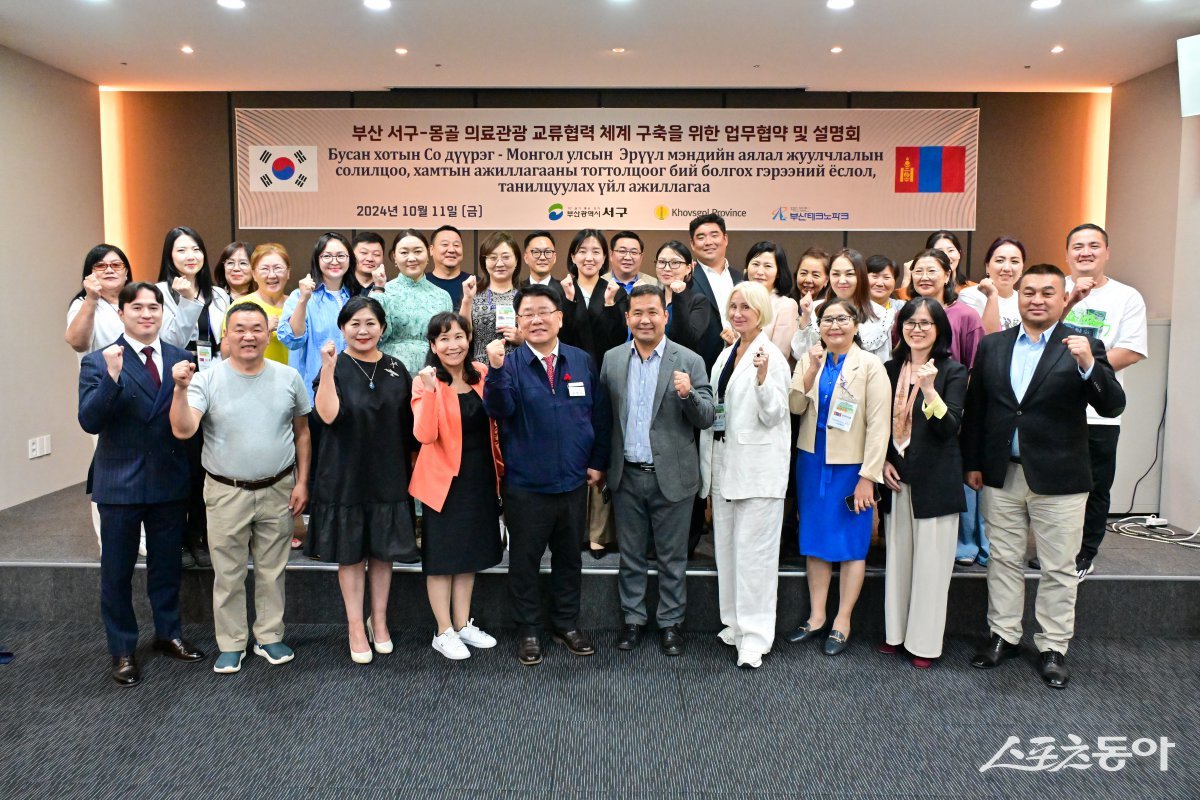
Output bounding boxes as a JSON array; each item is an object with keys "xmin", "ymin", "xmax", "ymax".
[{"xmin": 600, "ymin": 285, "xmax": 715, "ymax": 656}]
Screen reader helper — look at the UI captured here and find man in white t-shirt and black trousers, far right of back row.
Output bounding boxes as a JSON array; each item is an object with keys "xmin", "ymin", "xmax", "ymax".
[{"xmin": 1063, "ymin": 223, "xmax": 1150, "ymax": 579}]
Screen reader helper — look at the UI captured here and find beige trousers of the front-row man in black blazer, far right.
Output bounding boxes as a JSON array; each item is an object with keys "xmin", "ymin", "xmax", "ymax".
[{"xmin": 979, "ymin": 464, "xmax": 1087, "ymax": 655}]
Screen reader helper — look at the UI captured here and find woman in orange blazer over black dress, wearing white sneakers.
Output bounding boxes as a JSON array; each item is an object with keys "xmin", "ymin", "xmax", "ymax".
[{"xmin": 409, "ymin": 312, "xmax": 503, "ymax": 661}]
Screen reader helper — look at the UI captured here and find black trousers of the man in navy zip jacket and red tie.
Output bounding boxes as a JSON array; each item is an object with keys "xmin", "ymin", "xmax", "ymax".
[{"xmin": 504, "ymin": 486, "xmax": 588, "ymax": 631}]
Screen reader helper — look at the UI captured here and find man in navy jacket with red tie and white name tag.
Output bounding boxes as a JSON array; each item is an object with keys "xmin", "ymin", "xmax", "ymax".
[{"xmin": 484, "ymin": 284, "xmax": 612, "ymax": 666}]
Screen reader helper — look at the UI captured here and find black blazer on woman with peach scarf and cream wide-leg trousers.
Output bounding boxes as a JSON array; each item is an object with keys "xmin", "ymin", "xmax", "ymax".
[{"xmin": 884, "ymin": 359, "xmax": 967, "ymax": 519}]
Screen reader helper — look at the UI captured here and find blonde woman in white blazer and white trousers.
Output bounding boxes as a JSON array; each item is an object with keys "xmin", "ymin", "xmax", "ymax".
[{"xmin": 700, "ymin": 281, "xmax": 791, "ymax": 668}]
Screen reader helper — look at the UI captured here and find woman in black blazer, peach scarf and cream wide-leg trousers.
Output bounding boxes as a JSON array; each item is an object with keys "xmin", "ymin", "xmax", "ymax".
[{"xmin": 880, "ymin": 297, "xmax": 967, "ymax": 669}]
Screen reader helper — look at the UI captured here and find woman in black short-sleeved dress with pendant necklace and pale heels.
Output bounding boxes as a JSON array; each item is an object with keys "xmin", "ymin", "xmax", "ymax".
[{"xmin": 304, "ymin": 296, "xmax": 418, "ymax": 663}]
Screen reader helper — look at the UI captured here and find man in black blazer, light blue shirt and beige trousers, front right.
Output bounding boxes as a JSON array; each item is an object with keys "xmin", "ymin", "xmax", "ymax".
[{"xmin": 962, "ymin": 264, "xmax": 1126, "ymax": 688}]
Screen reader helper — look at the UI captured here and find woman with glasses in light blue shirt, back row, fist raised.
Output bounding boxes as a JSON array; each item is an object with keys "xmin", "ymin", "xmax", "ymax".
[{"xmin": 276, "ymin": 233, "xmax": 354, "ymax": 402}]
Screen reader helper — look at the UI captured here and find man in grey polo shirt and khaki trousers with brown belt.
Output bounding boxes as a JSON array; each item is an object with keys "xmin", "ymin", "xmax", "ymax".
[{"xmin": 170, "ymin": 303, "xmax": 312, "ymax": 673}]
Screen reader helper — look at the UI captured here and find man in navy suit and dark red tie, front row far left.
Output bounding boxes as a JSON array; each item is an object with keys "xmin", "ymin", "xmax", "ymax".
[{"xmin": 79, "ymin": 283, "xmax": 204, "ymax": 686}]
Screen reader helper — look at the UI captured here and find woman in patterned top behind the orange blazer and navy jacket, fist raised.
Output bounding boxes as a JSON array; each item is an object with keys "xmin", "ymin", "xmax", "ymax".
[{"xmin": 462, "ymin": 230, "xmax": 521, "ymax": 363}]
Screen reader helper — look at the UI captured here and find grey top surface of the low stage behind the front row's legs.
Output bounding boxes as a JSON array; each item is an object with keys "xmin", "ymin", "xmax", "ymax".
[{"xmin": 0, "ymin": 483, "xmax": 1200, "ymax": 581}]
